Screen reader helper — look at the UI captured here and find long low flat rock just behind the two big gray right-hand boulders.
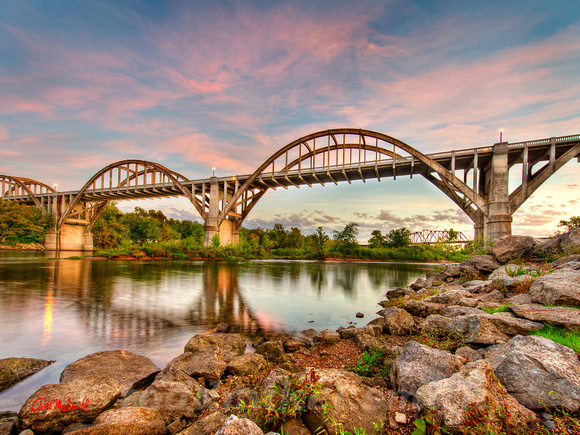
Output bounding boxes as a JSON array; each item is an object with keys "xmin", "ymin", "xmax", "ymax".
[{"xmin": 423, "ymin": 307, "xmax": 542, "ymax": 344}]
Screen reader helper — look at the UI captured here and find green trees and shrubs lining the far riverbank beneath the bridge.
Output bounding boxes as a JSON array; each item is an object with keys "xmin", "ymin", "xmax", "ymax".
[{"xmin": 0, "ymin": 201, "xmax": 473, "ymax": 263}]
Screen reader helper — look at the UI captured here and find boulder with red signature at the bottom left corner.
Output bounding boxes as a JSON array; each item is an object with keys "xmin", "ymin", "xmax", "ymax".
[{"xmin": 18, "ymin": 376, "xmax": 121, "ymax": 433}]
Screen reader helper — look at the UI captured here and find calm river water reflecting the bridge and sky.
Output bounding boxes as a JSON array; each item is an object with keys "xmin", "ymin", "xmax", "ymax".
[{"xmin": 0, "ymin": 251, "xmax": 440, "ymax": 411}]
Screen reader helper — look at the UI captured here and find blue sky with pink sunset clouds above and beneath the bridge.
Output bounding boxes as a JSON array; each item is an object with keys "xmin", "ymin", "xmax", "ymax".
[{"xmin": 0, "ymin": 0, "xmax": 580, "ymax": 241}]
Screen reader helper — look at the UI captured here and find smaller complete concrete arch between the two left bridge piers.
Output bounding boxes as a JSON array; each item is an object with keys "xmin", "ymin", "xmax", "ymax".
[{"xmin": 57, "ymin": 159, "xmax": 205, "ymax": 231}]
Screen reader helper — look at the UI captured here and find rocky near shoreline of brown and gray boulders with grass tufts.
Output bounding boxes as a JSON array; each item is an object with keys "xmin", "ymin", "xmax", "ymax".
[{"xmin": 0, "ymin": 229, "xmax": 580, "ymax": 435}]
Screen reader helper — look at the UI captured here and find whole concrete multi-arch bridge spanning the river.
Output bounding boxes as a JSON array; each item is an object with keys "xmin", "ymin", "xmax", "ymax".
[{"xmin": 0, "ymin": 129, "xmax": 580, "ymax": 250}]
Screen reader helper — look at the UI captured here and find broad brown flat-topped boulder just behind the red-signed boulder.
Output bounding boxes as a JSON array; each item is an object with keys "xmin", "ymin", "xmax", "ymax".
[{"xmin": 60, "ymin": 350, "xmax": 160, "ymax": 397}]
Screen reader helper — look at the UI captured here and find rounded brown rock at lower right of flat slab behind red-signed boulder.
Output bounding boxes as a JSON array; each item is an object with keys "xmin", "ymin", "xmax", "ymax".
[{"xmin": 139, "ymin": 381, "xmax": 202, "ymax": 425}]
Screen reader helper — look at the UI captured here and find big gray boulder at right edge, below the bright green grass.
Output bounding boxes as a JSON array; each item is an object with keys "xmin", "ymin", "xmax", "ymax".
[{"xmin": 487, "ymin": 335, "xmax": 580, "ymax": 410}]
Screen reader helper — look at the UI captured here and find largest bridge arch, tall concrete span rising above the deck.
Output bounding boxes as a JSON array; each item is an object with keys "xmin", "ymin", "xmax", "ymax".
[{"xmin": 216, "ymin": 128, "xmax": 486, "ymax": 228}]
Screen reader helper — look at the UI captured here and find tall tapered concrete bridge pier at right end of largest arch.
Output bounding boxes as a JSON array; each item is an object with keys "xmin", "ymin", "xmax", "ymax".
[{"xmin": 486, "ymin": 142, "xmax": 513, "ymax": 240}]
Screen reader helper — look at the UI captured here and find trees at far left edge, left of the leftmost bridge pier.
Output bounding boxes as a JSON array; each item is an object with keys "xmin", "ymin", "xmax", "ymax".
[{"xmin": 0, "ymin": 200, "xmax": 52, "ymax": 243}]
